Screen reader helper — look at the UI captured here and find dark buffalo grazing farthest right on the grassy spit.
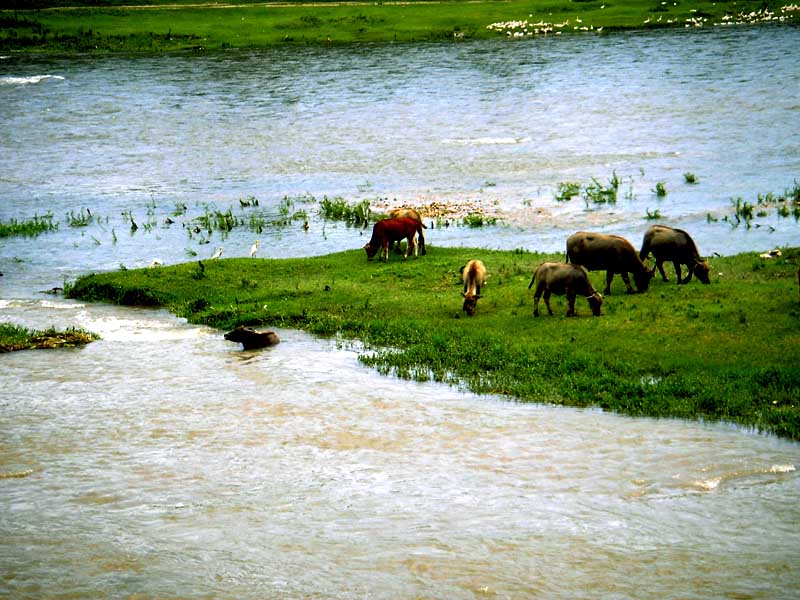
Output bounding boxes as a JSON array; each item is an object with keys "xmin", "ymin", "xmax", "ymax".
[{"xmin": 639, "ymin": 225, "xmax": 711, "ymax": 284}]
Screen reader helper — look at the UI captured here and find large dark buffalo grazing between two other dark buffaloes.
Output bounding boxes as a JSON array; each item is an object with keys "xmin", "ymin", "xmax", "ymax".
[{"xmin": 567, "ymin": 231, "xmax": 655, "ymax": 294}]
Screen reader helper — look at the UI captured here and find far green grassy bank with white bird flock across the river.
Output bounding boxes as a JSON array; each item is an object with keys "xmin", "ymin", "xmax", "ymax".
[{"xmin": 0, "ymin": 0, "xmax": 800, "ymax": 52}]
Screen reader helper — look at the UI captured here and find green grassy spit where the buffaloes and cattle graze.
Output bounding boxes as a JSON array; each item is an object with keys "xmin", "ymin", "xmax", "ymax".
[{"xmin": 67, "ymin": 248, "xmax": 800, "ymax": 439}]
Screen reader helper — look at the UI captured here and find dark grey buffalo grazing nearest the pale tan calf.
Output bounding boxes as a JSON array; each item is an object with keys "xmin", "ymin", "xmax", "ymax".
[{"xmin": 528, "ymin": 262, "xmax": 603, "ymax": 317}]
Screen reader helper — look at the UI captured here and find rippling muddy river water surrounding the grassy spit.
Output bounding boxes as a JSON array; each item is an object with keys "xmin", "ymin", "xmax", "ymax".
[{"xmin": 0, "ymin": 27, "xmax": 800, "ymax": 599}]
